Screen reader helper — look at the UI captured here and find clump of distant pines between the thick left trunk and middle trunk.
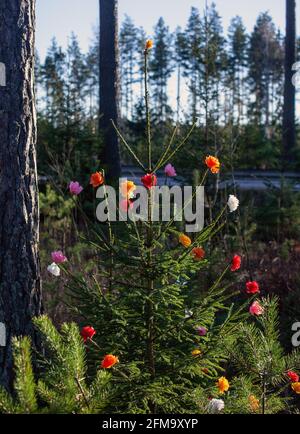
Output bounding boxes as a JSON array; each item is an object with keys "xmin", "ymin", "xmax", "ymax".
[{"xmin": 37, "ymin": 35, "xmax": 101, "ymax": 187}]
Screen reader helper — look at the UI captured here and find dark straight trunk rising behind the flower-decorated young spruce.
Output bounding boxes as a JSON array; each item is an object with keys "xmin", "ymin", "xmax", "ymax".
[{"xmin": 99, "ymin": 0, "xmax": 120, "ymax": 178}]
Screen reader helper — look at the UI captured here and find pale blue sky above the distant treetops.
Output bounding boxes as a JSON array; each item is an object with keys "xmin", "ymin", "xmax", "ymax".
[{"xmin": 36, "ymin": 0, "xmax": 300, "ymax": 58}]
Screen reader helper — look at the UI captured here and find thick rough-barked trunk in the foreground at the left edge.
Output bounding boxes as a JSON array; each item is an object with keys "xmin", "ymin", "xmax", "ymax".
[{"xmin": 0, "ymin": 0, "xmax": 41, "ymax": 389}]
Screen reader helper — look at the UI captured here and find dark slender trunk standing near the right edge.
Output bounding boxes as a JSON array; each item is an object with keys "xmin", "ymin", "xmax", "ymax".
[{"xmin": 283, "ymin": 0, "xmax": 296, "ymax": 161}]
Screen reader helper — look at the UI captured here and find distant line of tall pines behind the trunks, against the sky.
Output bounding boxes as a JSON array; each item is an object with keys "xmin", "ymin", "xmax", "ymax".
[{"xmin": 36, "ymin": 4, "xmax": 300, "ymax": 176}]
